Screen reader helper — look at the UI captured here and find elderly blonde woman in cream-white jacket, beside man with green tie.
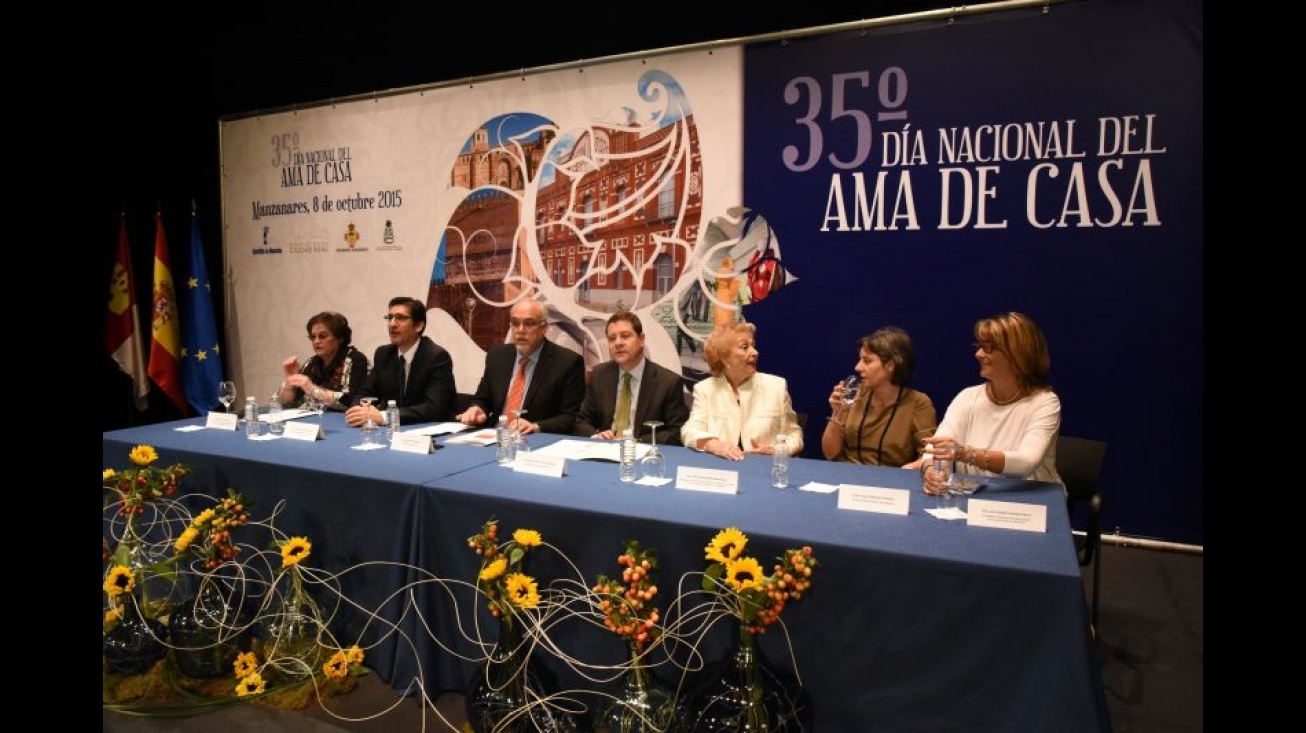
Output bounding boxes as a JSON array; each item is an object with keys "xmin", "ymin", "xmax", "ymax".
[{"xmin": 680, "ymin": 321, "xmax": 803, "ymax": 461}]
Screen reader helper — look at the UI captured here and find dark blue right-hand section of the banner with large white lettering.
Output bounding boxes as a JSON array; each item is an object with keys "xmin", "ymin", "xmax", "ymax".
[{"xmin": 743, "ymin": 0, "xmax": 1203, "ymax": 544}]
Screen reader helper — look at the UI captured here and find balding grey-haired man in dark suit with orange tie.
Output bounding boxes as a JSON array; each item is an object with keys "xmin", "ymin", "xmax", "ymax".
[{"xmin": 456, "ymin": 298, "xmax": 585, "ymax": 435}]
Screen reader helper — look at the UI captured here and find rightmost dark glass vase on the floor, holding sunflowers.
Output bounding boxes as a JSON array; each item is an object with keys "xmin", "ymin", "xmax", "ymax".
[{"xmin": 677, "ymin": 623, "xmax": 812, "ymax": 733}]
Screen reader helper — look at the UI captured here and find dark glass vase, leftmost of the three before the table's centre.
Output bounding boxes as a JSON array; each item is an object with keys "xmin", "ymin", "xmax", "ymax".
[{"xmin": 465, "ymin": 618, "xmax": 579, "ymax": 733}]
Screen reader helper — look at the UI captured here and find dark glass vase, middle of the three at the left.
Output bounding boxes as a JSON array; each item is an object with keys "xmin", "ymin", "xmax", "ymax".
[{"xmin": 168, "ymin": 574, "xmax": 249, "ymax": 679}]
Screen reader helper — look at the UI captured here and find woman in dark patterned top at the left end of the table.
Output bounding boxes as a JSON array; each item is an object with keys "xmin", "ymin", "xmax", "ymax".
[{"xmin": 277, "ymin": 311, "xmax": 367, "ymax": 410}]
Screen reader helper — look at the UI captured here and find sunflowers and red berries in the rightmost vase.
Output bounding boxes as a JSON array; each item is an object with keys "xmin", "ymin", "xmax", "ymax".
[{"xmin": 703, "ymin": 527, "xmax": 818, "ymax": 634}]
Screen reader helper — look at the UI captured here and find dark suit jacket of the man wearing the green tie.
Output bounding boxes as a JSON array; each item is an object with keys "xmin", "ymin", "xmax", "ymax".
[{"xmin": 575, "ymin": 354, "xmax": 690, "ymax": 446}]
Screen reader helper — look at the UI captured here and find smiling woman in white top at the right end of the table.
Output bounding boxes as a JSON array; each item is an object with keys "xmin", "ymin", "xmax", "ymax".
[{"xmin": 902, "ymin": 311, "xmax": 1062, "ymax": 494}]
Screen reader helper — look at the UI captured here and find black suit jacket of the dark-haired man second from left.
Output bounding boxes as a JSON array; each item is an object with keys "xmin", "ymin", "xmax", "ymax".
[{"xmin": 351, "ymin": 336, "xmax": 453, "ymax": 426}]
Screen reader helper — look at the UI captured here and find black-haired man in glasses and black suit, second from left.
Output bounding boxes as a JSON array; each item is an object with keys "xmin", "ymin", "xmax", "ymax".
[{"xmin": 345, "ymin": 295, "xmax": 453, "ymax": 427}]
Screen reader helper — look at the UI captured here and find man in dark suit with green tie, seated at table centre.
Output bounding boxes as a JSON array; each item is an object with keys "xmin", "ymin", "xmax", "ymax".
[{"xmin": 575, "ymin": 311, "xmax": 690, "ymax": 446}]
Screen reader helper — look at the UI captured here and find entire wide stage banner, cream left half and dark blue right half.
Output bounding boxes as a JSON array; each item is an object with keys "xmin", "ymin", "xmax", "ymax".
[{"xmin": 222, "ymin": 0, "xmax": 1203, "ymax": 542}]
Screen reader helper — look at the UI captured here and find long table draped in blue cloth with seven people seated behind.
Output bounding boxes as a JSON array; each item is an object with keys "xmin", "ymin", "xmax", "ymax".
[{"xmin": 104, "ymin": 414, "xmax": 1110, "ymax": 732}]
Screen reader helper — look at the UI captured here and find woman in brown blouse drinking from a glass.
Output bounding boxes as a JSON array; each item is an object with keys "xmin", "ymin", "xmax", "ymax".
[{"xmin": 820, "ymin": 325, "xmax": 936, "ymax": 466}]
